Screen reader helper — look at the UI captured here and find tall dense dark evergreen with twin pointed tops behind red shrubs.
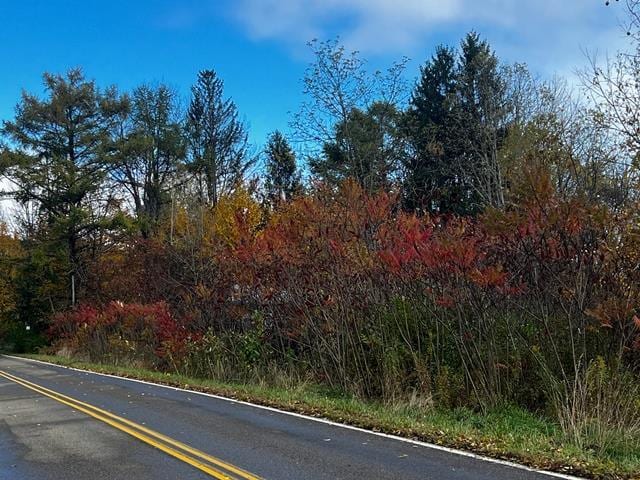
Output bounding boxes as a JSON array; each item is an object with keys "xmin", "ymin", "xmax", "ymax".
[{"xmin": 405, "ymin": 32, "xmax": 509, "ymax": 215}]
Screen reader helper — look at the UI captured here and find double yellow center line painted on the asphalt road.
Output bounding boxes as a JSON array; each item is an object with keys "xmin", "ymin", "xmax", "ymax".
[{"xmin": 0, "ymin": 370, "xmax": 261, "ymax": 480}]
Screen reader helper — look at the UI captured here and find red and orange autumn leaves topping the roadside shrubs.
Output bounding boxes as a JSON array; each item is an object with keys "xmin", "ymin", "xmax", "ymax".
[{"xmin": 52, "ymin": 178, "xmax": 640, "ymax": 366}]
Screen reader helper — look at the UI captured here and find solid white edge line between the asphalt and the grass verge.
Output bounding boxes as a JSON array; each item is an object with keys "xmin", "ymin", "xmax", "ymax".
[{"xmin": 2, "ymin": 355, "xmax": 584, "ymax": 480}]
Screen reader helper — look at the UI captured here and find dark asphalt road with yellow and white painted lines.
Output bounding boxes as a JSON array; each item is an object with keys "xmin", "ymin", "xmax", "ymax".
[{"xmin": 0, "ymin": 357, "xmax": 576, "ymax": 480}]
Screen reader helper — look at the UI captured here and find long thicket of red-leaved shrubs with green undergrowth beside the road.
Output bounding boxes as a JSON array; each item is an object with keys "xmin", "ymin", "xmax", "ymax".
[{"xmin": 51, "ymin": 178, "xmax": 640, "ymax": 404}]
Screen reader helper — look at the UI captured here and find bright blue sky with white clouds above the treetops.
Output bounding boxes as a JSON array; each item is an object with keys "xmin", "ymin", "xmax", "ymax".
[{"xmin": 0, "ymin": 0, "xmax": 624, "ymax": 148}]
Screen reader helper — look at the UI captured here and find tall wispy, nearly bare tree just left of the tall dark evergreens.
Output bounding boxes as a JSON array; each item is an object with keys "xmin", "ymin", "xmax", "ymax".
[{"xmin": 292, "ymin": 40, "xmax": 406, "ymax": 190}]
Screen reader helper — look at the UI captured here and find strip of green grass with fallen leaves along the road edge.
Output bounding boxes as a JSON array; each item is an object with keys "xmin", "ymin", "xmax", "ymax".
[{"xmin": 15, "ymin": 355, "xmax": 640, "ymax": 479}]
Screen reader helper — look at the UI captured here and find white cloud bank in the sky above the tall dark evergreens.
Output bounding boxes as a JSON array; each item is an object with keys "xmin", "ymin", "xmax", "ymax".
[{"xmin": 232, "ymin": 0, "xmax": 623, "ymax": 70}]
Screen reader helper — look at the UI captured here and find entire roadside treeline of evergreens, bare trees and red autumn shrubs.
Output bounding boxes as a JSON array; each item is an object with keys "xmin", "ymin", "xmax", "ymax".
[{"xmin": 0, "ymin": 17, "xmax": 640, "ymax": 458}]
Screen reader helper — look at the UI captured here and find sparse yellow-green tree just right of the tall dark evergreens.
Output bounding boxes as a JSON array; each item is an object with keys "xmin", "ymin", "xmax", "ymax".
[{"xmin": 499, "ymin": 75, "xmax": 632, "ymax": 209}]
